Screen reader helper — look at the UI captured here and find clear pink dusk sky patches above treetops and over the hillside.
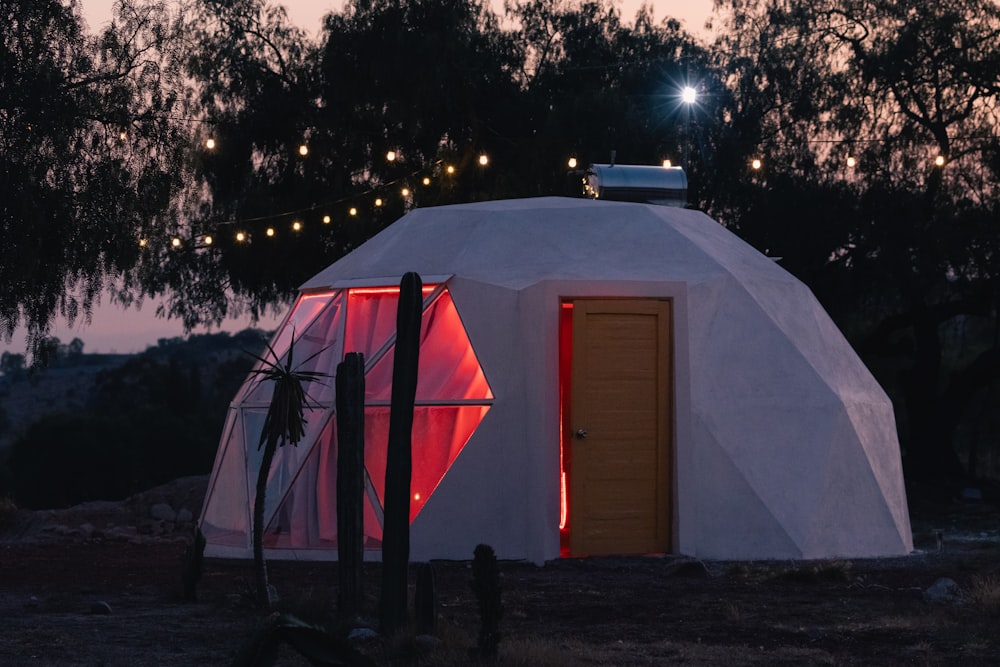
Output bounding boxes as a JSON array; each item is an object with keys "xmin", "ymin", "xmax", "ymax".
[{"xmin": 0, "ymin": 0, "xmax": 712, "ymax": 354}]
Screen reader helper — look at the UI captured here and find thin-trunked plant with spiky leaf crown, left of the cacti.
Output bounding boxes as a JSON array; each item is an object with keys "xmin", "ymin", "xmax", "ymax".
[{"xmin": 248, "ymin": 329, "xmax": 329, "ymax": 609}]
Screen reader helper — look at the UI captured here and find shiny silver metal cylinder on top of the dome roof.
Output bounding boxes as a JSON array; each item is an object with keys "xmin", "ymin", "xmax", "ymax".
[{"xmin": 583, "ymin": 164, "xmax": 687, "ymax": 206}]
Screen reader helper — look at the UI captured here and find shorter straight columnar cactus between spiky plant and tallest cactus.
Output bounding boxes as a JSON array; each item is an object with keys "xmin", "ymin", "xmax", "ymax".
[{"xmin": 336, "ymin": 352, "xmax": 365, "ymax": 622}]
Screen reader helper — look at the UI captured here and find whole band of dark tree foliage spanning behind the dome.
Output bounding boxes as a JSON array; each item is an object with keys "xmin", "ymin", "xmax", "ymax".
[{"xmin": 0, "ymin": 0, "xmax": 1000, "ymax": 482}]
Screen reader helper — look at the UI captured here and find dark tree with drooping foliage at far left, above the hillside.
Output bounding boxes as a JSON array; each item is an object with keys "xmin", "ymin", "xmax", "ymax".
[{"xmin": 0, "ymin": 0, "xmax": 186, "ymax": 346}]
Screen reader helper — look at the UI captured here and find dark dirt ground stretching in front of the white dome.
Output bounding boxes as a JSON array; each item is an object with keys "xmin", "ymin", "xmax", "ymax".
[{"xmin": 0, "ymin": 486, "xmax": 1000, "ymax": 667}]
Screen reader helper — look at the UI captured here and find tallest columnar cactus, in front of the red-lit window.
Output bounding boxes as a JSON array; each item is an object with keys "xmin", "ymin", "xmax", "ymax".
[{"xmin": 379, "ymin": 273, "xmax": 423, "ymax": 635}]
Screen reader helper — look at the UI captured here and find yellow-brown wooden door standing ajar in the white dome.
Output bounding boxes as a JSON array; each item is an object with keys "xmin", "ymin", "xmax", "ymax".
[{"xmin": 568, "ymin": 299, "xmax": 673, "ymax": 555}]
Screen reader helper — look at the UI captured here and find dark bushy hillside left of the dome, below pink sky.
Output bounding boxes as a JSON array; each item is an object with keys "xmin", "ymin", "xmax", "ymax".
[{"xmin": 0, "ymin": 329, "xmax": 269, "ymax": 509}]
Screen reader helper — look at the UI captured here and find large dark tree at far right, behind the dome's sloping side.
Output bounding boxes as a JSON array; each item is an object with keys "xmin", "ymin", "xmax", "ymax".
[{"xmin": 714, "ymin": 0, "xmax": 1000, "ymax": 476}]
